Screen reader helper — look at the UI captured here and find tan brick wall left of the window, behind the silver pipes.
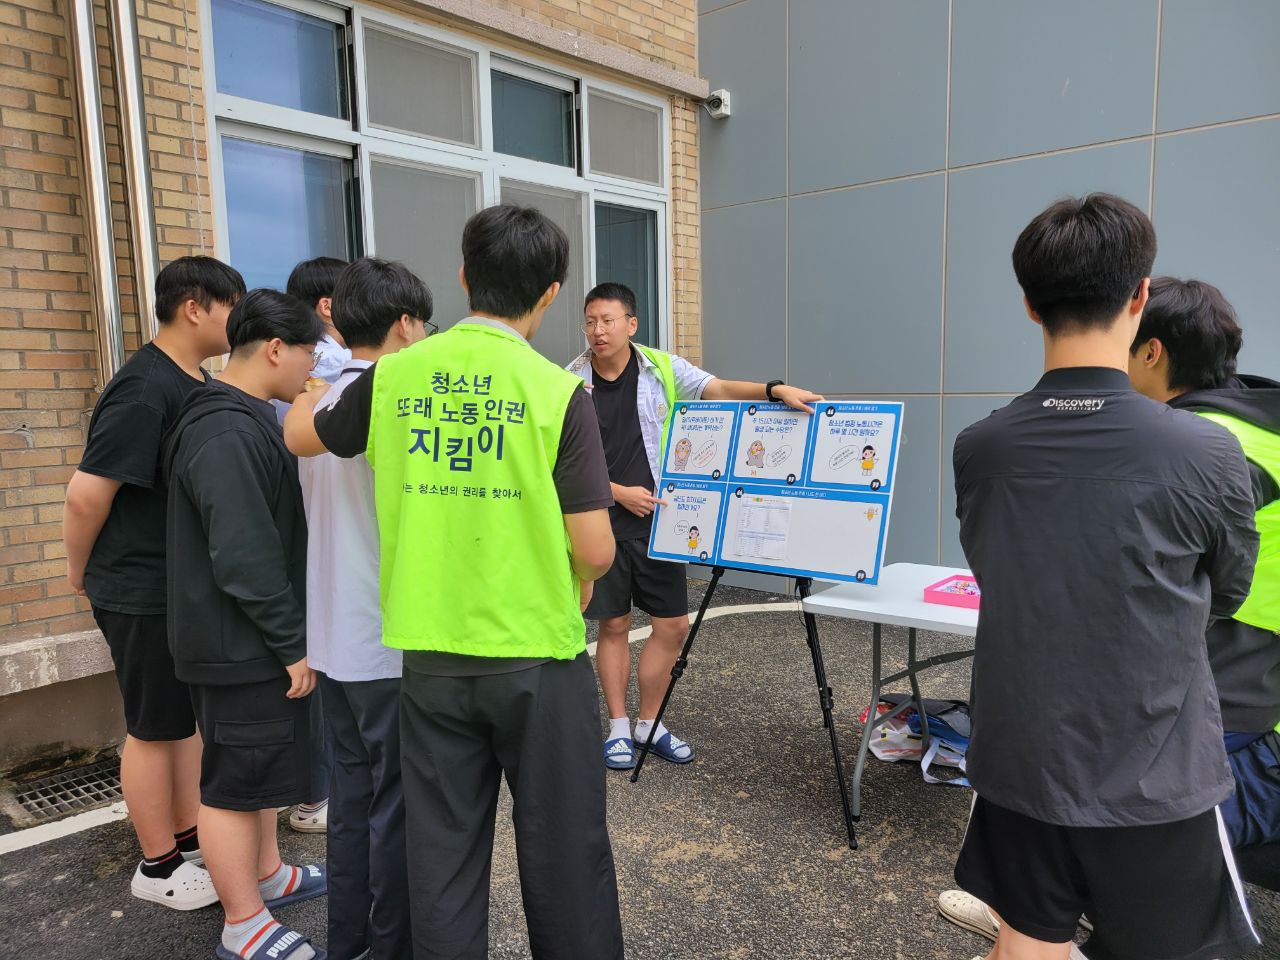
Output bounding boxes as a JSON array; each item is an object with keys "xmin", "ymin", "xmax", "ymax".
[{"xmin": 0, "ymin": 0, "xmax": 212, "ymax": 643}]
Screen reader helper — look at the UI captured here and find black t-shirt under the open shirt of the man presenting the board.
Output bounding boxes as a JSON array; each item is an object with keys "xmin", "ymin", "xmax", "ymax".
[{"xmin": 591, "ymin": 347, "xmax": 653, "ymax": 540}]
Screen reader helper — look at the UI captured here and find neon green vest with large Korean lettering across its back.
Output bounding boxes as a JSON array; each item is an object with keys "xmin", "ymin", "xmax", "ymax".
[{"xmin": 367, "ymin": 323, "xmax": 585, "ymax": 659}]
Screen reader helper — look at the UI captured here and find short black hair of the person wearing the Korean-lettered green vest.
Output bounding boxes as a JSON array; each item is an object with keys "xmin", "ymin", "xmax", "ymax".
[{"xmin": 462, "ymin": 205, "xmax": 568, "ymax": 319}]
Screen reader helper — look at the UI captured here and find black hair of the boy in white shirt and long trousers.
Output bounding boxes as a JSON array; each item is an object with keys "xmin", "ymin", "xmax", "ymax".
[{"xmin": 333, "ymin": 257, "xmax": 433, "ymax": 347}]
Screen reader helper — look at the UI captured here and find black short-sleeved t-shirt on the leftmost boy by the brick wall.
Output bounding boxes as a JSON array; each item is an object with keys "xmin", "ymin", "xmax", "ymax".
[{"xmin": 79, "ymin": 343, "xmax": 209, "ymax": 614}]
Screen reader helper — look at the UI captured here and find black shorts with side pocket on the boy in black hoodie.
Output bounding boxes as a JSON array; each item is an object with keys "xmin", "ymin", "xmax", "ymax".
[{"xmin": 191, "ymin": 669, "xmax": 311, "ymax": 810}]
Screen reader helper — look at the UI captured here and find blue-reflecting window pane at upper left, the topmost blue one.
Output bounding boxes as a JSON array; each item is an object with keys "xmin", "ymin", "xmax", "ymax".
[{"xmin": 212, "ymin": 0, "xmax": 351, "ymax": 119}]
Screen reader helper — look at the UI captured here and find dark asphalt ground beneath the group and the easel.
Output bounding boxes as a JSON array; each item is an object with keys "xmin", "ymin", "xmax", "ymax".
[{"xmin": 0, "ymin": 584, "xmax": 1280, "ymax": 960}]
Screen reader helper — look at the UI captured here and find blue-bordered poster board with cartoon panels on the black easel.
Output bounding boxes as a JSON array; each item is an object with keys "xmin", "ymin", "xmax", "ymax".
[{"xmin": 649, "ymin": 401, "xmax": 902, "ymax": 584}]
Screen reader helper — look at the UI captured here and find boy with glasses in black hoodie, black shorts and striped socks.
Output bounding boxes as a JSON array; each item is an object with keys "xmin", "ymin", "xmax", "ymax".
[{"xmin": 165, "ymin": 289, "xmax": 325, "ymax": 960}]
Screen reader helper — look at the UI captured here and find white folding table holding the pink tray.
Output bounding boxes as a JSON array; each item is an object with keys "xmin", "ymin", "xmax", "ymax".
[{"xmin": 804, "ymin": 563, "xmax": 978, "ymax": 819}]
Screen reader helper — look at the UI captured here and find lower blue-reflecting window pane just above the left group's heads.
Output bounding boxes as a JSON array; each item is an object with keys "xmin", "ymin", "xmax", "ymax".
[{"xmin": 223, "ymin": 137, "xmax": 356, "ymax": 291}]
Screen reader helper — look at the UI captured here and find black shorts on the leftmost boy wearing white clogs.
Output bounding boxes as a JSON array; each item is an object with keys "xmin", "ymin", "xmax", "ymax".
[{"xmin": 93, "ymin": 607, "xmax": 196, "ymax": 741}]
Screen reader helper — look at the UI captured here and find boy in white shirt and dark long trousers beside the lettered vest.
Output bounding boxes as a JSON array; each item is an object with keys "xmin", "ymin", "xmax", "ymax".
[{"xmin": 298, "ymin": 257, "xmax": 435, "ymax": 960}]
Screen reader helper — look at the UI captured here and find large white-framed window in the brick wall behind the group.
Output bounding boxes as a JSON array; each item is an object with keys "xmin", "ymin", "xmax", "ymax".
[{"xmin": 202, "ymin": 0, "xmax": 669, "ymax": 362}]
